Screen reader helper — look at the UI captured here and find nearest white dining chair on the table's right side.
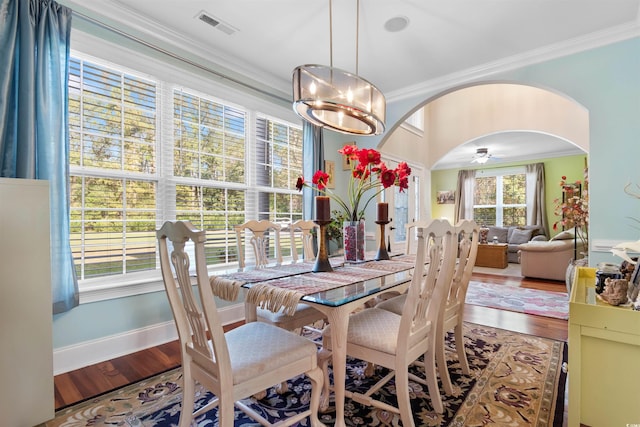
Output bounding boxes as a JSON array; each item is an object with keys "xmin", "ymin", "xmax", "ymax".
[{"xmin": 320, "ymin": 220, "xmax": 457, "ymax": 426}]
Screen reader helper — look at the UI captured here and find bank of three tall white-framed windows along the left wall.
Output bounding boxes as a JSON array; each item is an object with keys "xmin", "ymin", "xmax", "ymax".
[{"xmin": 69, "ymin": 54, "xmax": 302, "ymax": 286}]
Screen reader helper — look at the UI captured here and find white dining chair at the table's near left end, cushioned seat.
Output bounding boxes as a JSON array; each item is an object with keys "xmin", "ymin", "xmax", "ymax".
[{"xmin": 156, "ymin": 221, "xmax": 323, "ymax": 427}]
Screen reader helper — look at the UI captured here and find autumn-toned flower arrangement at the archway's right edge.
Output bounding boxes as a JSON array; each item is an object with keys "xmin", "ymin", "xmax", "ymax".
[{"xmin": 553, "ymin": 168, "xmax": 589, "ymax": 247}]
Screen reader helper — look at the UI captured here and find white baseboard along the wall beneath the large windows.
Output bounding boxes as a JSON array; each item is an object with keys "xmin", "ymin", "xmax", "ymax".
[{"xmin": 53, "ymin": 304, "xmax": 244, "ymax": 375}]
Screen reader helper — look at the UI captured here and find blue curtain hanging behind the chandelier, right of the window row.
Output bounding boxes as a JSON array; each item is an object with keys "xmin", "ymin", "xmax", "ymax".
[{"xmin": 302, "ymin": 120, "xmax": 324, "ymax": 220}]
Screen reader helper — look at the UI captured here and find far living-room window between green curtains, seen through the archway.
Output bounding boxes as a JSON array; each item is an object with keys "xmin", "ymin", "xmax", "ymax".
[{"xmin": 473, "ymin": 170, "xmax": 527, "ymax": 226}]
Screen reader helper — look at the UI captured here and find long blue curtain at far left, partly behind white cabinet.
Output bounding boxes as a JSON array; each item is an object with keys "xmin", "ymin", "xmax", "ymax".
[{"xmin": 0, "ymin": 0, "xmax": 78, "ymax": 314}]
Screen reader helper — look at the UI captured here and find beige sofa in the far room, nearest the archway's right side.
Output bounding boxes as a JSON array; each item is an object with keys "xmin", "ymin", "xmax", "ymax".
[{"xmin": 519, "ymin": 230, "xmax": 586, "ymax": 281}]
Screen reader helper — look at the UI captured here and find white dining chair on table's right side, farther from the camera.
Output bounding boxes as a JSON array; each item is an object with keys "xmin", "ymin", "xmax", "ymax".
[{"xmin": 376, "ymin": 220, "xmax": 480, "ymax": 395}]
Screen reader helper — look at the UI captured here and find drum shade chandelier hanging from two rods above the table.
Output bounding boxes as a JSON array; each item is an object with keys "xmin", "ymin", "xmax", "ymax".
[{"xmin": 293, "ymin": 0, "xmax": 386, "ymax": 135}]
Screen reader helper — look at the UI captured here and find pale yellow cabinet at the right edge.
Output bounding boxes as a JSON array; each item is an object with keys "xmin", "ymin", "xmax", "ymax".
[{"xmin": 569, "ymin": 267, "xmax": 640, "ymax": 427}]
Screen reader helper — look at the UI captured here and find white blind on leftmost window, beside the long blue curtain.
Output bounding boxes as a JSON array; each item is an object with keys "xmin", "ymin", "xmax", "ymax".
[{"xmin": 69, "ymin": 58, "xmax": 157, "ymax": 279}]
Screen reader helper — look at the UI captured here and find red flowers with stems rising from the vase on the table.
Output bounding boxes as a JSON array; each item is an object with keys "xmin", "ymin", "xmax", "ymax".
[{"xmin": 296, "ymin": 144, "xmax": 411, "ymax": 221}]
